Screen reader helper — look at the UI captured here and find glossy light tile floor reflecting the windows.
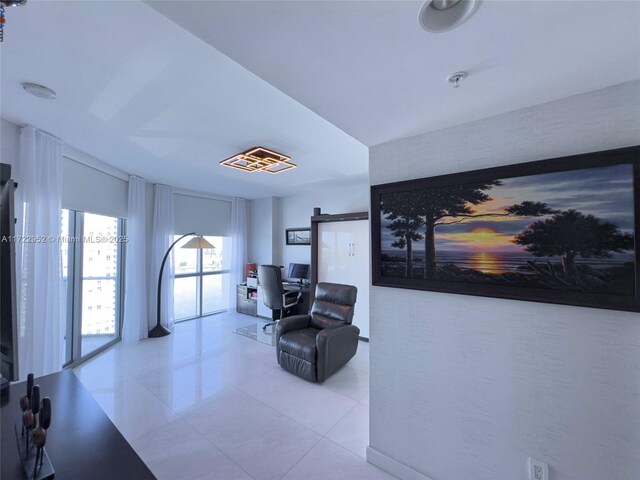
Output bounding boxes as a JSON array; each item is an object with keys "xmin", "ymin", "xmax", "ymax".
[{"xmin": 75, "ymin": 312, "xmax": 394, "ymax": 480}]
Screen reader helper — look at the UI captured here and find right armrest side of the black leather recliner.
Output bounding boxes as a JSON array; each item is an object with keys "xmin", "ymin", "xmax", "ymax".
[{"xmin": 316, "ymin": 325, "xmax": 360, "ymax": 382}]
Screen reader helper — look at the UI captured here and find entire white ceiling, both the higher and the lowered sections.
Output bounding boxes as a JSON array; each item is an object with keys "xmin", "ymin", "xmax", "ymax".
[{"xmin": 0, "ymin": 0, "xmax": 640, "ymax": 198}]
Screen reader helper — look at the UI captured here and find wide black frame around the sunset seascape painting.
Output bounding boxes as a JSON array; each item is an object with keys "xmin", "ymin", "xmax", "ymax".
[{"xmin": 371, "ymin": 146, "xmax": 640, "ymax": 312}]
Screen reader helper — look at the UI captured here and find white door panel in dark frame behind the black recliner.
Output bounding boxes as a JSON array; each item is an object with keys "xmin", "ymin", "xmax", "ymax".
[{"xmin": 318, "ymin": 220, "xmax": 369, "ymax": 338}]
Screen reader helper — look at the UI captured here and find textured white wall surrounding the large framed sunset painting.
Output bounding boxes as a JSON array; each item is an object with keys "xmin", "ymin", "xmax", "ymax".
[{"xmin": 368, "ymin": 82, "xmax": 640, "ymax": 480}]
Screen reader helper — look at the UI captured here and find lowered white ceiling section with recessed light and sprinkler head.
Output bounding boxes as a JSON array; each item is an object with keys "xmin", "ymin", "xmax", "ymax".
[{"xmin": 149, "ymin": 0, "xmax": 640, "ymax": 146}]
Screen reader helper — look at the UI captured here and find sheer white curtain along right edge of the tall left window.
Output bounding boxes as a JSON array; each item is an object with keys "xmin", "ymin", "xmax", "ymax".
[{"xmin": 122, "ymin": 175, "xmax": 152, "ymax": 343}]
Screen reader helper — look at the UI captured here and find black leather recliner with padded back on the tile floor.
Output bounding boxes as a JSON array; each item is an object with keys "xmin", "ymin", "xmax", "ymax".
[{"xmin": 276, "ymin": 283, "xmax": 360, "ymax": 382}]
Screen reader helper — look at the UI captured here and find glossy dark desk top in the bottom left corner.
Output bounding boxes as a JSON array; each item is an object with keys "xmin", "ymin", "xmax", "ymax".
[{"xmin": 0, "ymin": 370, "xmax": 156, "ymax": 480}]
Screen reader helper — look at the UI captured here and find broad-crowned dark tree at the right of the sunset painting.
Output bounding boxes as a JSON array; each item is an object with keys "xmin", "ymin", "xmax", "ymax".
[{"xmin": 513, "ymin": 210, "xmax": 634, "ymax": 283}]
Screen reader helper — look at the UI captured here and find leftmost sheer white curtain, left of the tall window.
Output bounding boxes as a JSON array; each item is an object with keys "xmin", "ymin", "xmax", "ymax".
[{"xmin": 16, "ymin": 126, "xmax": 65, "ymax": 379}]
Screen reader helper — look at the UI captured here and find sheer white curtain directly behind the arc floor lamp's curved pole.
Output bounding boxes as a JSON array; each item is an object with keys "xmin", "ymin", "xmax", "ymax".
[{"xmin": 148, "ymin": 185, "xmax": 174, "ymax": 329}]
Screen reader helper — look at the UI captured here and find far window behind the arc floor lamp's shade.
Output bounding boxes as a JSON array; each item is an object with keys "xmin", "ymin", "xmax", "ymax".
[{"xmin": 173, "ymin": 235, "xmax": 231, "ymax": 321}]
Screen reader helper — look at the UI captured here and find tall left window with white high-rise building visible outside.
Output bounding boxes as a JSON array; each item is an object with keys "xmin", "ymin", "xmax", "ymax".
[{"xmin": 62, "ymin": 210, "xmax": 124, "ymax": 363}]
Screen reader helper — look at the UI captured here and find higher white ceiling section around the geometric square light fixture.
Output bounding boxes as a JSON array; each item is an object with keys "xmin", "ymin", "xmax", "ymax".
[{"xmin": 0, "ymin": 0, "xmax": 368, "ymax": 198}]
